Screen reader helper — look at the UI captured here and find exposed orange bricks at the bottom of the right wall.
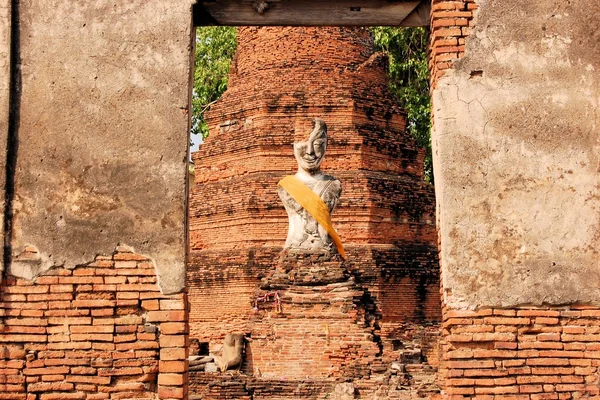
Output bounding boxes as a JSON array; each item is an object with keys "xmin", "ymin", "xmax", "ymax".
[{"xmin": 440, "ymin": 306, "xmax": 600, "ymax": 400}]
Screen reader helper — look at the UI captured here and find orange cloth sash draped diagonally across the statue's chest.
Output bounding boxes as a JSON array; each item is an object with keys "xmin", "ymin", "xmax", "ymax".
[{"xmin": 278, "ymin": 175, "xmax": 346, "ymax": 260}]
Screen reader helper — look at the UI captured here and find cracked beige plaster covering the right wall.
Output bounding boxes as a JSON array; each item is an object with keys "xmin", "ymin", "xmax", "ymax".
[{"xmin": 433, "ymin": 0, "xmax": 600, "ymax": 309}]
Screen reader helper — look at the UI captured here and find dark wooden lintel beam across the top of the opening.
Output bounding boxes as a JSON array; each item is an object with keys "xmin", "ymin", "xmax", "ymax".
[{"xmin": 194, "ymin": 0, "xmax": 430, "ymax": 26}]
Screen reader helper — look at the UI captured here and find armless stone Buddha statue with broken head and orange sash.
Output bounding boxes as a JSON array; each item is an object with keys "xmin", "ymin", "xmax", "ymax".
[{"xmin": 278, "ymin": 118, "xmax": 345, "ymax": 257}]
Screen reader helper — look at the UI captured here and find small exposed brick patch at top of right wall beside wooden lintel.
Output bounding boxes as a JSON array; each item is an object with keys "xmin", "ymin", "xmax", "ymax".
[{"xmin": 429, "ymin": 0, "xmax": 477, "ymax": 89}]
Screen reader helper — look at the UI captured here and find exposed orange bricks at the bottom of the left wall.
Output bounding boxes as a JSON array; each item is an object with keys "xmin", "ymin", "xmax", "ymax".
[{"xmin": 0, "ymin": 247, "xmax": 187, "ymax": 400}]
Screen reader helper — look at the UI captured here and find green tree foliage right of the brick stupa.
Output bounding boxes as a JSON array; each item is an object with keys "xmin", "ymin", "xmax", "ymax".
[{"xmin": 371, "ymin": 27, "xmax": 433, "ymax": 183}]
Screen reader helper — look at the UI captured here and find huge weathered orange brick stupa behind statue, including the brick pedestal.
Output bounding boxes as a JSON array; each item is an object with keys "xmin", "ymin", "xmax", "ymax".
[{"xmin": 187, "ymin": 27, "xmax": 440, "ymax": 398}]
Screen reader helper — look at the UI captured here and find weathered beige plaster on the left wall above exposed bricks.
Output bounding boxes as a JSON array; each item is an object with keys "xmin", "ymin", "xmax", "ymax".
[{"xmin": 7, "ymin": 0, "xmax": 193, "ymax": 293}]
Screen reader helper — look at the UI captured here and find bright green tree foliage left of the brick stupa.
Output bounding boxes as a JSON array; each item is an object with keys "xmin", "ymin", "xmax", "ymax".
[{"xmin": 191, "ymin": 26, "xmax": 237, "ymax": 139}]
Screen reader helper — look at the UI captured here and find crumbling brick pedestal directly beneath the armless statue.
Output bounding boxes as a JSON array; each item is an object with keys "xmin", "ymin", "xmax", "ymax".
[{"xmin": 253, "ymin": 250, "xmax": 381, "ymax": 379}]
